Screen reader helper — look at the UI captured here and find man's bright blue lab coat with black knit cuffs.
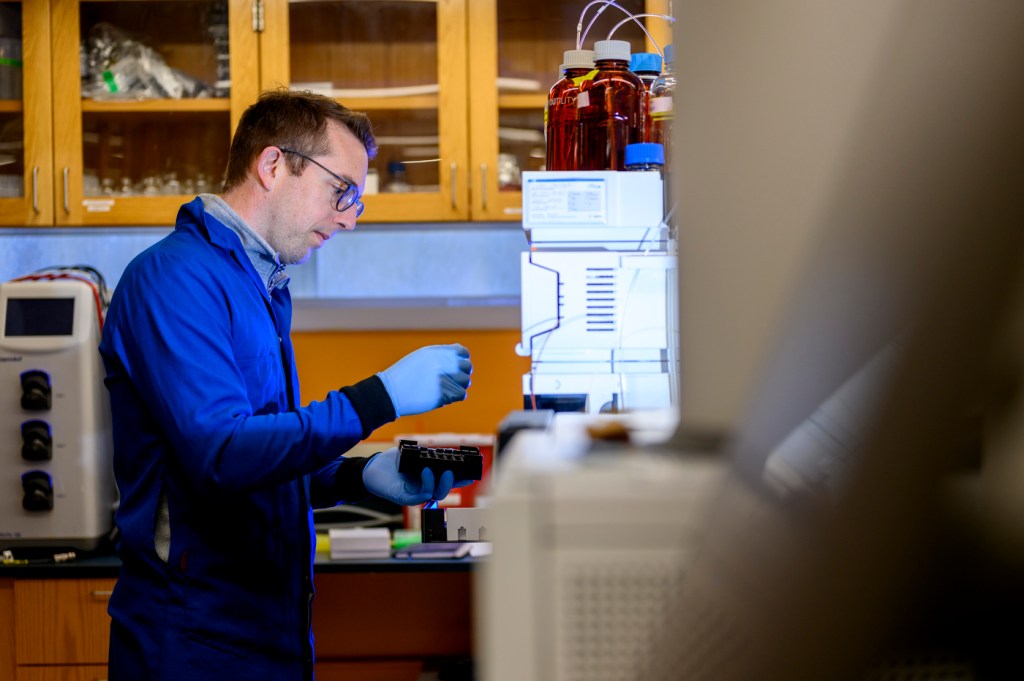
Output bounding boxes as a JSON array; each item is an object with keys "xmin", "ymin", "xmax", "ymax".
[{"xmin": 99, "ymin": 199, "xmax": 395, "ymax": 681}]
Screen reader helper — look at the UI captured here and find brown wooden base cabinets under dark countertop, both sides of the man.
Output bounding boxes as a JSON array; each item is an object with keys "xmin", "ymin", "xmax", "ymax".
[{"xmin": 0, "ymin": 555, "xmax": 480, "ymax": 681}]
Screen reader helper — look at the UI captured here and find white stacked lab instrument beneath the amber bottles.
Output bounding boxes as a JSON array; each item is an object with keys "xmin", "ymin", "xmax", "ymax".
[{"xmin": 516, "ymin": 171, "xmax": 677, "ymax": 414}]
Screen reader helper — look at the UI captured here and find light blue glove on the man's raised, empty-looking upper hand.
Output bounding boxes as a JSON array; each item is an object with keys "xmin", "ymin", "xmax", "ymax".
[{"xmin": 377, "ymin": 343, "xmax": 473, "ymax": 416}]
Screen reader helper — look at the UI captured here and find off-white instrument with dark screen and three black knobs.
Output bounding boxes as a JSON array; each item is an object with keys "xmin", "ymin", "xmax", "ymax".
[{"xmin": 0, "ymin": 279, "xmax": 117, "ymax": 550}]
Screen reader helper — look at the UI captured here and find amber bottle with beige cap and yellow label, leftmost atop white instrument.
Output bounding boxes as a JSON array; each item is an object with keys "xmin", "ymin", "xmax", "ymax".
[{"xmin": 544, "ymin": 49, "xmax": 594, "ymax": 170}]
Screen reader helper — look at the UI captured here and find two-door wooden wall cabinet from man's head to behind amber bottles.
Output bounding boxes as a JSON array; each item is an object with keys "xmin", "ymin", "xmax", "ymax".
[{"xmin": 260, "ymin": 0, "xmax": 671, "ymax": 222}]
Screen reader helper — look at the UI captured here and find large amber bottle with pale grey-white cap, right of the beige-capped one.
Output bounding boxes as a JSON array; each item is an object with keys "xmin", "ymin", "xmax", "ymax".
[{"xmin": 577, "ymin": 40, "xmax": 644, "ymax": 170}]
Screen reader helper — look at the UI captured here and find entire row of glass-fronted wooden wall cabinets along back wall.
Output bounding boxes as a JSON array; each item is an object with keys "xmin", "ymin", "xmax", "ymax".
[{"xmin": 0, "ymin": 0, "xmax": 671, "ymax": 226}]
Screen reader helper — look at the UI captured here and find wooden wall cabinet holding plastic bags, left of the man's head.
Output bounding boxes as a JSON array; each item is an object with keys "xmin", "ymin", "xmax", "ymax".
[{"xmin": 0, "ymin": 0, "xmax": 259, "ymax": 226}]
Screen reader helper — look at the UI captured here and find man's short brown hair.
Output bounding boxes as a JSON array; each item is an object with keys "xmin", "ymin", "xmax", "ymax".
[{"xmin": 224, "ymin": 88, "xmax": 377, "ymax": 191}]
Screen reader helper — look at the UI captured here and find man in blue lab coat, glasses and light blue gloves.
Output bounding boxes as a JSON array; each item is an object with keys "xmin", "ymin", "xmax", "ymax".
[{"xmin": 99, "ymin": 90, "xmax": 472, "ymax": 681}]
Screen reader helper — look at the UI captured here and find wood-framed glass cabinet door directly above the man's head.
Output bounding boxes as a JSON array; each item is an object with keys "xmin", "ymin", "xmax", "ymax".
[{"xmin": 261, "ymin": 0, "xmax": 469, "ymax": 222}]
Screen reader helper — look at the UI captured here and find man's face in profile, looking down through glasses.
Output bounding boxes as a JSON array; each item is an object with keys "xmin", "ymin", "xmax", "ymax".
[{"xmin": 265, "ymin": 123, "xmax": 368, "ymax": 264}]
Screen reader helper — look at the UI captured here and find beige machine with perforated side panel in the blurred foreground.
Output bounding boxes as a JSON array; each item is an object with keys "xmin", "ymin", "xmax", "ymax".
[{"xmin": 475, "ymin": 410, "xmax": 726, "ymax": 681}]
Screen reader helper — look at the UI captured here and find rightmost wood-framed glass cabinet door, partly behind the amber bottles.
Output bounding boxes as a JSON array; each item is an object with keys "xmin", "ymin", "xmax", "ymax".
[{"xmin": 469, "ymin": 0, "xmax": 671, "ymax": 220}]
